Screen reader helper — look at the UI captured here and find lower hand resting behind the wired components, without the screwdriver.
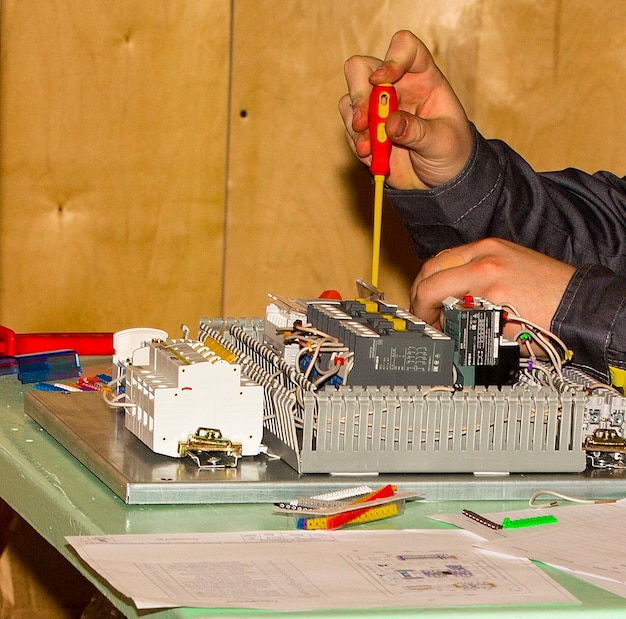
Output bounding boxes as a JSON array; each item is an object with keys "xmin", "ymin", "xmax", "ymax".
[{"xmin": 411, "ymin": 238, "xmax": 576, "ymax": 337}]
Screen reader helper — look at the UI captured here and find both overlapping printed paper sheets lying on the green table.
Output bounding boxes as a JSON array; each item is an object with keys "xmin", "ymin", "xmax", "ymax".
[{"xmin": 67, "ymin": 501, "xmax": 626, "ymax": 611}]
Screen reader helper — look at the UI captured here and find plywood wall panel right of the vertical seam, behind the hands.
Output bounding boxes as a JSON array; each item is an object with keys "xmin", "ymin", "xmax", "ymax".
[{"xmin": 225, "ymin": 0, "xmax": 626, "ymax": 314}]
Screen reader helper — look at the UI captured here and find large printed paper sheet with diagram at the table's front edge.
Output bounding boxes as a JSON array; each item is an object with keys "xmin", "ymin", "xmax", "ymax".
[{"xmin": 67, "ymin": 530, "xmax": 577, "ymax": 611}]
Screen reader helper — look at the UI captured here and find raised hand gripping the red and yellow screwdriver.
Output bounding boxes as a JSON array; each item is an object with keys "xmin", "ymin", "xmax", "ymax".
[{"xmin": 339, "ymin": 30, "xmax": 472, "ymax": 189}]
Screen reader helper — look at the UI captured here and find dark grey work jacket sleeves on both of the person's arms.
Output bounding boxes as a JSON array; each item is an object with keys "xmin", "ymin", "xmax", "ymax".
[{"xmin": 386, "ymin": 124, "xmax": 626, "ymax": 379}]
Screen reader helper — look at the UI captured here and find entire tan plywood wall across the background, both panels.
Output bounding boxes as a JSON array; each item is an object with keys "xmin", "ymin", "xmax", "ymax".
[{"xmin": 0, "ymin": 0, "xmax": 626, "ymax": 335}]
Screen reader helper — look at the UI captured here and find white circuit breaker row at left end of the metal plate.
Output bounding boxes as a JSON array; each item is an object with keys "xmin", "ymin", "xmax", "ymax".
[{"xmin": 116, "ymin": 333, "xmax": 263, "ymax": 457}]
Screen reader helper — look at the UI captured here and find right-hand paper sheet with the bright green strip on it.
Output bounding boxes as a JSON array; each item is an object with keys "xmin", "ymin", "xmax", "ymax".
[{"xmin": 433, "ymin": 501, "xmax": 626, "ymax": 597}]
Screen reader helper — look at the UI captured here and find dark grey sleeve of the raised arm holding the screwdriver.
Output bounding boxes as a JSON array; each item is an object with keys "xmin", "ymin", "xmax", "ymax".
[{"xmin": 386, "ymin": 124, "xmax": 626, "ymax": 273}]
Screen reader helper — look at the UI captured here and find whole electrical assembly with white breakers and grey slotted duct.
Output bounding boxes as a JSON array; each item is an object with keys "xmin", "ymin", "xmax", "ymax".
[{"xmin": 108, "ymin": 299, "xmax": 608, "ymax": 474}]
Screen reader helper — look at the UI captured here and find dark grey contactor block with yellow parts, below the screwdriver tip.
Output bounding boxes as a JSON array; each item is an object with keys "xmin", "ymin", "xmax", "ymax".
[{"xmin": 307, "ymin": 301, "xmax": 454, "ymax": 386}]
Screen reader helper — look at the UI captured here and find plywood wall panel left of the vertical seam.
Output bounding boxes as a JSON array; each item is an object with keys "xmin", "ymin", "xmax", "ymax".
[{"xmin": 0, "ymin": 0, "xmax": 230, "ymax": 331}]
